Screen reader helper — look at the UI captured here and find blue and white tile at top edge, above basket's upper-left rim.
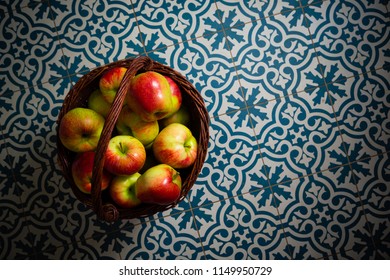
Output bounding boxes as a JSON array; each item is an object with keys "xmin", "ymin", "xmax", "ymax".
[{"xmin": 51, "ymin": 0, "xmax": 144, "ymax": 74}]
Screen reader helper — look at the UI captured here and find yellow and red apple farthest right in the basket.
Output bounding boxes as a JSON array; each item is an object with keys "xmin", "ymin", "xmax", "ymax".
[{"xmin": 152, "ymin": 123, "xmax": 198, "ymax": 168}]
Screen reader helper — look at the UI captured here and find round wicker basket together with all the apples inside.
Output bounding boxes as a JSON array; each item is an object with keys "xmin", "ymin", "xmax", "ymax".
[{"xmin": 57, "ymin": 56, "xmax": 209, "ymax": 222}]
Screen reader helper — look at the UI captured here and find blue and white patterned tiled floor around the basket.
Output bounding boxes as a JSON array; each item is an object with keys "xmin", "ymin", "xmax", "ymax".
[{"xmin": 0, "ymin": 0, "xmax": 390, "ymax": 259}]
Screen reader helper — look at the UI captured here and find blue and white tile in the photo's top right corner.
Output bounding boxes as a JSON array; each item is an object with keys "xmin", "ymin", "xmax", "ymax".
[{"xmin": 304, "ymin": 0, "xmax": 390, "ymax": 82}]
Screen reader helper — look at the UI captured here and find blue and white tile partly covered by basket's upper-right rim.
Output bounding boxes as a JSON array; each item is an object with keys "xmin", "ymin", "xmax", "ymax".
[{"xmin": 148, "ymin": 35, "xmax": 246, "ymax": 116}]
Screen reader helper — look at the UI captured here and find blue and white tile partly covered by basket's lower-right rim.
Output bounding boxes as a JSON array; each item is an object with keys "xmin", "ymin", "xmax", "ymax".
[{"xmin": 189, "ymin": 109, "xmax": 269, "ymax": 207}]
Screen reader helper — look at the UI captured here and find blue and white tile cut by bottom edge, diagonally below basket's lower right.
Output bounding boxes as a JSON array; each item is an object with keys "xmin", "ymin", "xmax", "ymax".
[{"xmin": 193, "ymin": 188, "xmax": 290, "ymax": 260}]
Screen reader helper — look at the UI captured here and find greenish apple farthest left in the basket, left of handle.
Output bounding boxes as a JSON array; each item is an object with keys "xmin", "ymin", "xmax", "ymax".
[{"xmin": 58, "ymin": 107, "xmax": 104, "ymax": 153}]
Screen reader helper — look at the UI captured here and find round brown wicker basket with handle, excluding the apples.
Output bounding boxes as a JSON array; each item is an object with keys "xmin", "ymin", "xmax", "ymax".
[{"xmin": 57, "ymin": 56, "xmax": 209, "ymax": 222}]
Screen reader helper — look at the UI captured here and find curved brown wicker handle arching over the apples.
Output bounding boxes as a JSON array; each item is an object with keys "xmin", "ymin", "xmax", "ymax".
[{"xmin": 91, "ymin": 56, "xmax": 153, "ymax": 222}]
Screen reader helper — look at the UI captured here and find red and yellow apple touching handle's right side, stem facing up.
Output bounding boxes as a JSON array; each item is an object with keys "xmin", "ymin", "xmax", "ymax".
[{"xmin": 104, "ymin": 135, "xmax": 146, "ymax": 175}]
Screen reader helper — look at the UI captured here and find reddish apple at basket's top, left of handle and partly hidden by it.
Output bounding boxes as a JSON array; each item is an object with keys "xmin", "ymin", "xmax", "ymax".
[{"xmin": 99, "ymin": 67, "xmax": 127, "ymax": 104}]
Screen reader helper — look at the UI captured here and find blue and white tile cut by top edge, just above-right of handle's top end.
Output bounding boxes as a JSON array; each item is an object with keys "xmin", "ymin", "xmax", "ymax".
[{"xmin": 132, "ymin": 0, "xmax": 222, "ymax": 52}]
